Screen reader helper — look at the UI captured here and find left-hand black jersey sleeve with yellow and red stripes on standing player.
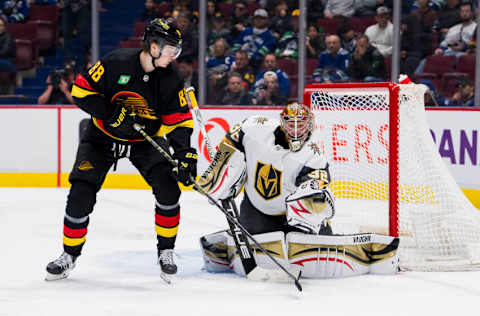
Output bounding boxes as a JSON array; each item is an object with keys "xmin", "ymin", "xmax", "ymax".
[{"xmin": 72, "ymin": 60, "xmax": 112, "ymax": 119}]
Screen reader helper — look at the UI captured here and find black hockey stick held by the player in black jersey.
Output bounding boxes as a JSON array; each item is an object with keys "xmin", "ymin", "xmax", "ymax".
[{"xmin": 133, "ymin": 123, "xmax": 302, "ymax": 291}]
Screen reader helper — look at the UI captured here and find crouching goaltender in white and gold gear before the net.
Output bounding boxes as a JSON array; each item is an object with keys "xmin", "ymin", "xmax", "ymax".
[{"xmin": 198, "ymin": 103, "xmax": 399, "ymax": 278}]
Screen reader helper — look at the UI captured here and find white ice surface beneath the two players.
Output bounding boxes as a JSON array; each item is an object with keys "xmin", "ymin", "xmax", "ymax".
[{"xmin": 0, "ymin": 188, "xmax": 480, "ymax": 316}]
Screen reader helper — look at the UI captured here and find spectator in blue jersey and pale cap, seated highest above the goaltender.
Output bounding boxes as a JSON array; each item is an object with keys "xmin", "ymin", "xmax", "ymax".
[{"xmin": 233, "ymin": 9, "xmax": 276, "ymax": 67}]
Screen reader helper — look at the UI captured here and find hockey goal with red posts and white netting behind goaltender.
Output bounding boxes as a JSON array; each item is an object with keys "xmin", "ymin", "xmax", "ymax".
[{"xmin": 304, "ymin": 83, "xmax": 480, "ymax": 271}]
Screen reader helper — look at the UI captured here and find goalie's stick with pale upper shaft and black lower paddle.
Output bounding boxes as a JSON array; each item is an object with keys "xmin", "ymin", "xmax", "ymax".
[{"xmin": 185, "ymin": 87, "xmax": 300, "ymax": 280}]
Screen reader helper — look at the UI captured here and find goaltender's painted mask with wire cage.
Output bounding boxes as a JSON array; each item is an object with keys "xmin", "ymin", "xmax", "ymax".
[{"xmin": 280, "ymin": 103, "xmax": 313, "ymax": 151}]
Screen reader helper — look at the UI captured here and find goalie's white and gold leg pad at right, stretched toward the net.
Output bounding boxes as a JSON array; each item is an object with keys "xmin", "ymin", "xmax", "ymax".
[{"xmin": 286, "ymin": 232, "xmax": 399, "ymax": 279}]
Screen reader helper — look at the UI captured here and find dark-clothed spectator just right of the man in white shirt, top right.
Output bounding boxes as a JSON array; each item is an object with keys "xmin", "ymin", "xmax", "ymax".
[{"xmin": 406, "ymin": 0, "xmax": 438, "ymax": 57}]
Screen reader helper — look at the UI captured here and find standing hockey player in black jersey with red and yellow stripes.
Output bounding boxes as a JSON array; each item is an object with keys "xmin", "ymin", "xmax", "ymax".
[{"xmin": 46, "ymin": 19, "xmax": 197, "ymax": 280}]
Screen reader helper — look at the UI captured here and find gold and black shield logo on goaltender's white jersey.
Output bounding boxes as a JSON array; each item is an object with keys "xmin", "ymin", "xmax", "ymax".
[{"xmin": 255, "ymin": 161, "xmax": 282, "ymax": 200}]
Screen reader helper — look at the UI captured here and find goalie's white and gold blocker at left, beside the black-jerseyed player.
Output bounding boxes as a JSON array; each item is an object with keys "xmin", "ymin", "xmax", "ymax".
[{"xmin": 198, "ymin": 141, "xmax": 246, "ymax": 200}]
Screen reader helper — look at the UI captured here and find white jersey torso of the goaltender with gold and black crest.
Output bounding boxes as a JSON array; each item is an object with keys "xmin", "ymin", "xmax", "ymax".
[{"xmin": 242, "ymin": 117, "xmax": 314, "ymax": 215}]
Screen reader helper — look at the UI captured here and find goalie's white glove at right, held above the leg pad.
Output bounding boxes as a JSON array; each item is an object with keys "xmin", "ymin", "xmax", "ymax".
[{"xmin": 285, "ymin": 179, "xmax": 335, "ymax": 234}]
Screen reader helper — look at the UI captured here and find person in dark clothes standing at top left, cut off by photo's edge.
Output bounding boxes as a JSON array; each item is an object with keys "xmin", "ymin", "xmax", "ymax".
[{"xmin": 62, "ymin": 0, "xmax": 92, "ymax": 67}]
